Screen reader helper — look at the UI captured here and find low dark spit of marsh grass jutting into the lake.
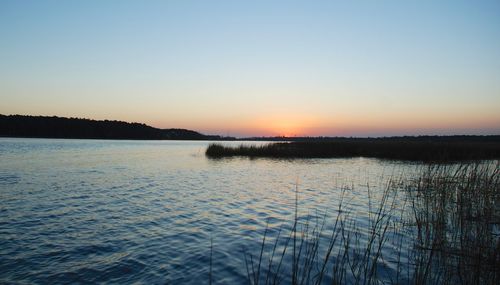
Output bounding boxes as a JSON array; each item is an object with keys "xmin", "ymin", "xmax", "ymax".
[{"xmin": 205, "ymin": 136, "xmax": 500, "ymax": 162}]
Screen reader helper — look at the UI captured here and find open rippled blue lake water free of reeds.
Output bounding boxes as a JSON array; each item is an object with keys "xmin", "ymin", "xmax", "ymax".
[{"xmin": 0, "ymin": 138, "xmax": 415, "ymax": 284}]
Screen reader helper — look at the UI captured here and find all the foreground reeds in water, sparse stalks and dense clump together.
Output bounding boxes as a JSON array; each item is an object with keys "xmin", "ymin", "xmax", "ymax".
[{"xmin": 216, "ymin": 161, "xmax": 500, "ymax": 284}]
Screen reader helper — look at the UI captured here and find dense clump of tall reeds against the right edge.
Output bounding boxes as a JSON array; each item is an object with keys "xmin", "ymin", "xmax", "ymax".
[{"xmin": 407, "ymin": 164, "xmax": 500, "ymax": 284}]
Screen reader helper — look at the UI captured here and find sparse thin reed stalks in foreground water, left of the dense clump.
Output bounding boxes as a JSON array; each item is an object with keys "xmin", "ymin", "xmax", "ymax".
[{"xmin": 240, "ymin": 182, "xmax": 395, "ymax": 284}]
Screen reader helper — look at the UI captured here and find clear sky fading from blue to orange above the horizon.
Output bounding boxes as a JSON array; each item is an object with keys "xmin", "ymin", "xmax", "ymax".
[{"xmin": 0, "ymin": 0, "xmax": 500, "ymax": 136}]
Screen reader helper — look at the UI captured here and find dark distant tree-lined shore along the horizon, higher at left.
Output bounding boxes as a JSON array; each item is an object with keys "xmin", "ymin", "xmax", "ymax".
[{"xmin": 0, "ymin": 114, "xmax": 500, "ymax": 143}]
